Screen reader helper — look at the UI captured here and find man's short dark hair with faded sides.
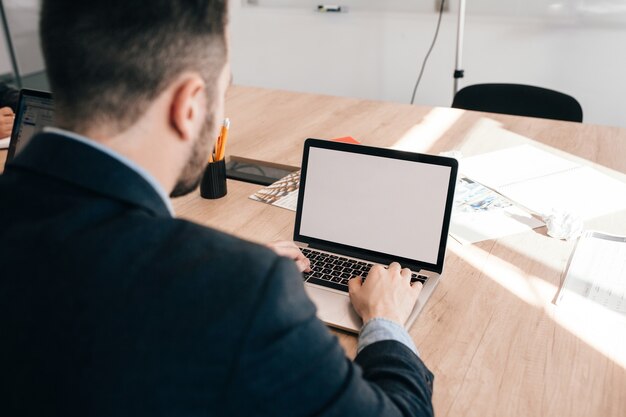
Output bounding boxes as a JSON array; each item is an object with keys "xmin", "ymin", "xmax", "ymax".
[{"xmin": 40, "ymin": 0, "xmax": 228, "ymax": 132}]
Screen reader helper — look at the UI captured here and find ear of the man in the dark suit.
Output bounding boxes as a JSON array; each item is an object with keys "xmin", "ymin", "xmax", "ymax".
[{"xmin": 170, "ymin": 74, "xmax": 207, "ymax": 141}]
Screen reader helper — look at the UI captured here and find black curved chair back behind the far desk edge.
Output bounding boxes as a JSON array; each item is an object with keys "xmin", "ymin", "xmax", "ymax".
[{"xmin": 452, "ymin": 84, "xmax": 583, "ymax": 122}]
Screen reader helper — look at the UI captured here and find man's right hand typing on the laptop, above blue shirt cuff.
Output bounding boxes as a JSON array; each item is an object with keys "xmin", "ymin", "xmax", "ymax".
[{"xmin": 348, "ymin": 262, "xmax": 422, "ymax": 326}]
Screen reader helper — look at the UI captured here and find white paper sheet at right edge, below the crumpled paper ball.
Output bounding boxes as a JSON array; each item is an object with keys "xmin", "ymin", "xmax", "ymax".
[{"xmin": 556, "ymin": 231, "xmax": 626, "ymax": 323}]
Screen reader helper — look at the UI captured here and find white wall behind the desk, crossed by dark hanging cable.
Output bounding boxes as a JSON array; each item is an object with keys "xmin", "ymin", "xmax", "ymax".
[{"xmin": 231, "ymin": 0, "xmax": 626, "ymax": 127}]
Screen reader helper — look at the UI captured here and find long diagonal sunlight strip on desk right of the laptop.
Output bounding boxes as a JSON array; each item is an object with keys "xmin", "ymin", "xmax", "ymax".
[{"xmin": 449, "ymin": 245, "xmax": 626, "ymax": 369}]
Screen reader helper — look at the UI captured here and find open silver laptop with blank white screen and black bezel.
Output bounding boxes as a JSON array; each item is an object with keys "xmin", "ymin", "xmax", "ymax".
[{"xmin": 294, "ymin": 139, "xmax": 458, "ymax": 333}]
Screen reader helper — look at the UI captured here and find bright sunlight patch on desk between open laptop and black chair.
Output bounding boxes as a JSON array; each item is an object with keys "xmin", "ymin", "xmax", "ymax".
[{"xmin": 390, "ymin": 108, "xmax": 463, "ymax": 153}]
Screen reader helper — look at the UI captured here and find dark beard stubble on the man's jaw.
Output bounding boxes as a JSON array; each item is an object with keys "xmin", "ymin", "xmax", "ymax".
[{"xmin": 170, "ymin": 115, "xmax": 213, "ymax": 198}]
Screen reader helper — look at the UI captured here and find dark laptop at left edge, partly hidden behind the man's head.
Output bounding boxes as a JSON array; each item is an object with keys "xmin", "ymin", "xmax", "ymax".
[{"xmin": 7, "ymin": 89, "xmax": 54, "ymax": 162}]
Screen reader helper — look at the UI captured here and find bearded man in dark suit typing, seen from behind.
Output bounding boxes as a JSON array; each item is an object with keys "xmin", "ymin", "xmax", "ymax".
[{"xmin": 0, "ymin": 0, "xmax": 432, "ymax": 417}]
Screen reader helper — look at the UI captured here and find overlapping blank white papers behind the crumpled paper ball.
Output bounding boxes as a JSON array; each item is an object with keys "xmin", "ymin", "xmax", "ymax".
[{"xmin": 461, "ymin": 145, "xmax": 626, "ymax": 219}]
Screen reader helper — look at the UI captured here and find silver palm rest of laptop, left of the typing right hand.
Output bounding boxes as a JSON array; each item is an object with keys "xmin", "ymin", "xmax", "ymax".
[{"xmin": 304, "ymin": 285, "xmax": 363, "ymax": 333}]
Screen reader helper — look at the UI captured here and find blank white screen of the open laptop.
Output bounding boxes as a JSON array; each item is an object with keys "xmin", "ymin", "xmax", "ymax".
[{"xmin": 300, "ymin": 147, "xmax": 452, "ymax": 264}]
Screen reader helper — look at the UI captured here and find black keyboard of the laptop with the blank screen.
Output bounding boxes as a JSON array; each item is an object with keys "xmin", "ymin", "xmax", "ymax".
[{"xmin": 301, "ymin": 248, "xmax": 428, "ymax": 292}]
